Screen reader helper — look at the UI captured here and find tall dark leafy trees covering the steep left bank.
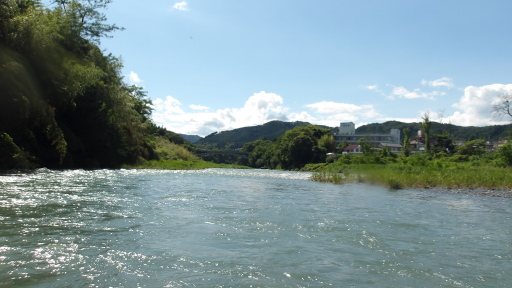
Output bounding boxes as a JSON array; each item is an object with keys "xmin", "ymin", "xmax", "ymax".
[{"xmin": 0, "ymin": 0, "xmax": 190, "ymax": 169}]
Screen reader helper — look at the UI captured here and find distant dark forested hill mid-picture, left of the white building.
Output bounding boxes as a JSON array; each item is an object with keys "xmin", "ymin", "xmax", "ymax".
[{"xmin": 195, "ymin": 120, "xmax": 320, "ymax": 149}]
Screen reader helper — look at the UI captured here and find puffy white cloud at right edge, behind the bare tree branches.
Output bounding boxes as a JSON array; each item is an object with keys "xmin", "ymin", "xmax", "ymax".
[{"xmin": 445, "ymin": 84, "xmax": 512, "ymax": 126}]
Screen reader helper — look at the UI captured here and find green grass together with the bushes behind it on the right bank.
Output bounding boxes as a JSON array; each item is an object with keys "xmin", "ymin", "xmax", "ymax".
[{"xmin": 303, "ymin": 139, "xmax": 512, "ymax": 189}]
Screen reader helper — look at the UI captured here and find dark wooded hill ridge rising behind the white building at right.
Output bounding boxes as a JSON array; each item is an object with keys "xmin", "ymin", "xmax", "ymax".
[{"xmin": 356, "ymin": 121, "xmax": 512, "ymax": 141}]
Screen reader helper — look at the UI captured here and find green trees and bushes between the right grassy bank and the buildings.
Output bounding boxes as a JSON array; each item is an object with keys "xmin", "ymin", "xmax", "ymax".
[{"xmin": 237, "ymin": 119, "xmax": 512, "ymax": 171}]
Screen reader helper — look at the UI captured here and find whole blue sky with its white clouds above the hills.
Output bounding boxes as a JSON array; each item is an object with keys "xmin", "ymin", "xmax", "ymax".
[{"xmin": 57, "ymin": 0, "xmax": 512, "ymax": 136}]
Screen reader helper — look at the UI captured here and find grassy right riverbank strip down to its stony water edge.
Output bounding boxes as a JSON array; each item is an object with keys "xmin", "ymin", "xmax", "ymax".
[{"xmin": 310, "ymin": 164, "xmax": 512, "ymax": 198}]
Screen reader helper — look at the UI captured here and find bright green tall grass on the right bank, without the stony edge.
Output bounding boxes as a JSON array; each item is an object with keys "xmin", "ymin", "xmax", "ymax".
[{"xmin": 306, "ymin": 157, "xmax": 512, "ymax": 190}]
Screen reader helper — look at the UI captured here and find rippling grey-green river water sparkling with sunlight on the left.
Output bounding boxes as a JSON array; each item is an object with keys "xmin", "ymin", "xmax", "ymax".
[{"xmin": 0, "ymin": 169, "xmax": 512, "ymax": 287}]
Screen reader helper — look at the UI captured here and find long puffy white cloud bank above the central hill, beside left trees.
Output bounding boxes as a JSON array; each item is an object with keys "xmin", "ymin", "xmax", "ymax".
[{"xmin": 153, "ymin": 91, "xmax": 380, "ymax": 136}]
